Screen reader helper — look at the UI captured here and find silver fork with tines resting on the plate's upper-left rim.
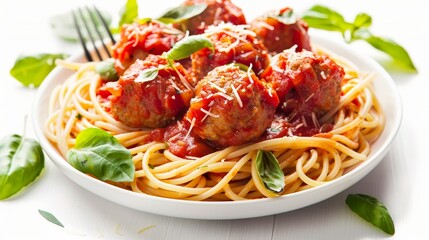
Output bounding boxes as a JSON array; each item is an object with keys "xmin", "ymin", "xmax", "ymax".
[{"xmin": 72, "ymin": 6, "xmax": 116, "ymax": 61}]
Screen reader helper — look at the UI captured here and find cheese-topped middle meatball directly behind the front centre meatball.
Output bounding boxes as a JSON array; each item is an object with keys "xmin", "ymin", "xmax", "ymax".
[{"xmin": 191, "ymin": 23, "xmax": 270, "ymax": 80}]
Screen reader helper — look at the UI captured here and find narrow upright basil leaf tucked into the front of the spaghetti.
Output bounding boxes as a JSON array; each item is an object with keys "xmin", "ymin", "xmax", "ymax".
[{"xmin": 256, "ymin": 150, "xmax": 285, "ymax": 193}]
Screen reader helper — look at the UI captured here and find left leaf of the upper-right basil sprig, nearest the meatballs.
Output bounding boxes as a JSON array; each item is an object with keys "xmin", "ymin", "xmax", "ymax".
[{"xmin": 301, "ymin": 5, "xmax": 351, "ymax": 33}]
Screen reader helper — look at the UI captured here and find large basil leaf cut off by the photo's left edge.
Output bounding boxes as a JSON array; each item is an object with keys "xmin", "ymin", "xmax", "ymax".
[{"xmin": 0, "ymin": 134, "xmax": 45, "ymax": 199}]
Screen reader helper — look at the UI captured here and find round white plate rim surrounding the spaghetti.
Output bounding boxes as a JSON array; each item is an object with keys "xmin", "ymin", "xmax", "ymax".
[{"xmin": 32, "ymin": 33, "xmax": 402, "ymax": 219}]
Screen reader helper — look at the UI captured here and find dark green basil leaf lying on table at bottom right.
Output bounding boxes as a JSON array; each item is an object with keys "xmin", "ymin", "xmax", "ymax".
[{"xmin": 346, "ymin": 194, "xmax": 395, "ymax": 235}]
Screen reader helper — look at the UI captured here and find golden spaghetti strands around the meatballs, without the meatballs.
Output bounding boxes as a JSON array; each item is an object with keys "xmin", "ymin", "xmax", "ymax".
[{"xmin": 45, "ymin": 44, "xmax": 385, "ymax": 201}]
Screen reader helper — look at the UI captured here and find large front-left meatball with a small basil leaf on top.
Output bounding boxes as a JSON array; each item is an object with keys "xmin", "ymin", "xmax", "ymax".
[{"xmin": 109, "ymin": 55, "xmax": 193, "ymax": 128}]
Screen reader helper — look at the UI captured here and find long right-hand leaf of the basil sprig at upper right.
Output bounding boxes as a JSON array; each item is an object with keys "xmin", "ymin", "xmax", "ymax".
[{"xmin": 353, "ymin": 29, "xmax": 417, "ymax": 72}]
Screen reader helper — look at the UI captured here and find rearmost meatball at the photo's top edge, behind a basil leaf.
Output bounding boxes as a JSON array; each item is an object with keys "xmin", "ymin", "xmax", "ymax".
[{"xmin": 174, "ymin": 0, "xmax": 246, "ymax": 35}]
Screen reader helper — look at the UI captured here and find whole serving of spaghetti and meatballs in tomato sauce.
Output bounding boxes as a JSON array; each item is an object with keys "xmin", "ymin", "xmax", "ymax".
[{"xmin": 45, "ymin": 0, "xmax": 385, "ymax": 201}]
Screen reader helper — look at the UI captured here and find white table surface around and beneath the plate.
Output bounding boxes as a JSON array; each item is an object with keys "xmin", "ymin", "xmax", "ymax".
[{"xmin": 0, "ymin": 0, "xmax": 429, "ymax": 240}]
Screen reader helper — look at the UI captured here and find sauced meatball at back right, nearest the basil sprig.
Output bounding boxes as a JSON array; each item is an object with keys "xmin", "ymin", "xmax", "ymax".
[{"xmin": 250, "ymin": 7, "xmax": 311, "ymax": 55}]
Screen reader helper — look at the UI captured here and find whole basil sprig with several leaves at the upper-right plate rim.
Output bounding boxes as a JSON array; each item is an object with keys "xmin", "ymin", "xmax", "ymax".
[{"xmin": 302, "ymin": 5, "xmax": 417, "ymax": 72}]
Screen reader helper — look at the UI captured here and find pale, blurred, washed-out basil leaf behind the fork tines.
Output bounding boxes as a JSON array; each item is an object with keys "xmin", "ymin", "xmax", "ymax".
[{"xmin": 49, "ymin": 8, "xmax": 112, "ymax": 42}]
